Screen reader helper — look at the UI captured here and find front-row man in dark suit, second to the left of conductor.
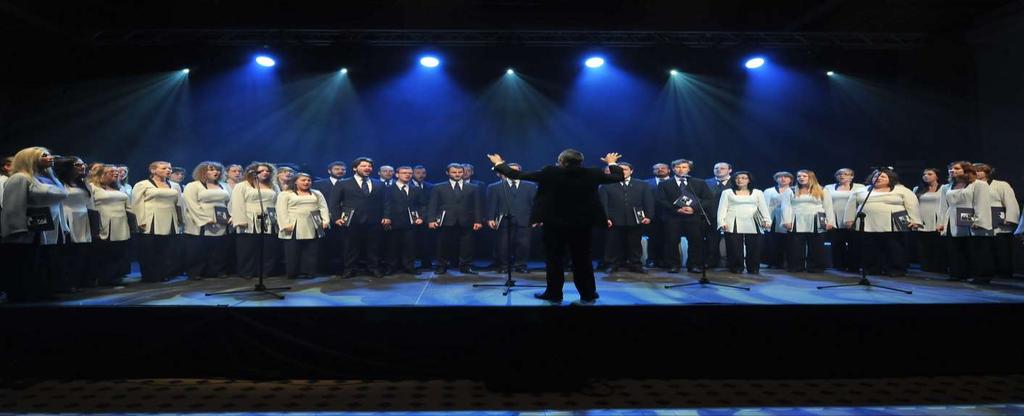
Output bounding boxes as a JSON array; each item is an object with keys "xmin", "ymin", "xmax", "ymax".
[{"xmin": 427, "ymin": 163, "xmax": 483, "ymax": 275}]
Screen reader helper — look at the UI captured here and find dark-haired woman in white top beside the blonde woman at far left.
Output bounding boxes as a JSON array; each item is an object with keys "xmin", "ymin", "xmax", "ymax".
[{"xmin": 53, "ymin": 156, "xmax": 99, "ymax": 292}]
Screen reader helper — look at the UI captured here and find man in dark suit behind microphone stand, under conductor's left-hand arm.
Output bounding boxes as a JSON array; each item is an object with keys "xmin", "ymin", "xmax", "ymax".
[{"xmin": 485, "ymin": 163, "xmax": 537, "ymax": 273}]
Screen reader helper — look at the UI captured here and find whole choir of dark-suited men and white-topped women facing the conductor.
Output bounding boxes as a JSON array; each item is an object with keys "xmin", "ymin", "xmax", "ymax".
[{"xmin": 0, "ymin": 147, "xmax": 1024, "ymax": 301}]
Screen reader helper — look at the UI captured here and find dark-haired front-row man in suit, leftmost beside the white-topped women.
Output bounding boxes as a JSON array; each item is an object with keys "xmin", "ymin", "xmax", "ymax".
[{"xmin": 328, "ymin": 157, "xmax": 391, "ymax": 279}]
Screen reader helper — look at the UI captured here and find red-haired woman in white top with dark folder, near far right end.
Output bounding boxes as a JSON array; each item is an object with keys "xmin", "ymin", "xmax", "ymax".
[{"xmin": 936, "ymin": 161, "xmax": 995, "ymax": 284}]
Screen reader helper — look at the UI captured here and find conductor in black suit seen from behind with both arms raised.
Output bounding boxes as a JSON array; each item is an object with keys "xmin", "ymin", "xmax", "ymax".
[{"xmin": 487, "ymin": 149, "xmax": 625, "ymax": 303}]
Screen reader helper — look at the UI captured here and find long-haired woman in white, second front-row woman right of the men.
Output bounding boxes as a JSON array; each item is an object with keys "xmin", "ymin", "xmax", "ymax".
[{"xmin": 782, "ymin": 169, "xmax": 836, "ymax": 273}]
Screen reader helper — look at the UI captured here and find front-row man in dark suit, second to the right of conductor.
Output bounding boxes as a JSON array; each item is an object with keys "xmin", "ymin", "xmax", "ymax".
[{"xmin": 656, "ymin": 159, "xmax": 714, "ymax": 273}]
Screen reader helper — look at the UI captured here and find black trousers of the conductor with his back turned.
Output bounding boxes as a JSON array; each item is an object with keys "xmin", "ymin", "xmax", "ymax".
[{"xmin": 544, "ymin": 225, "xmax": 597, "ymax": 298}]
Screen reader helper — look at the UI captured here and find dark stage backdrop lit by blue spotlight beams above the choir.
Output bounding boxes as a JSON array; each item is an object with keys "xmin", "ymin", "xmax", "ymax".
[{"xmin": 0, "ymin": 35, "xmax": 1022, "ymax": 188}]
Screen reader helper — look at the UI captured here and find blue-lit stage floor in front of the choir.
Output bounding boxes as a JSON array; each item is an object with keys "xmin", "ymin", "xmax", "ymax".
[{"xmin": 19, "ymin": 264, "xmax": 1024, "ymax": 306}]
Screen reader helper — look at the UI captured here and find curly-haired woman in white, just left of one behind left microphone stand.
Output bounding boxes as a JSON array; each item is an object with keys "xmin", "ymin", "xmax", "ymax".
[{"xmin": 182, "ymin": 161, "xmax": 231, "ymax": 280}]
